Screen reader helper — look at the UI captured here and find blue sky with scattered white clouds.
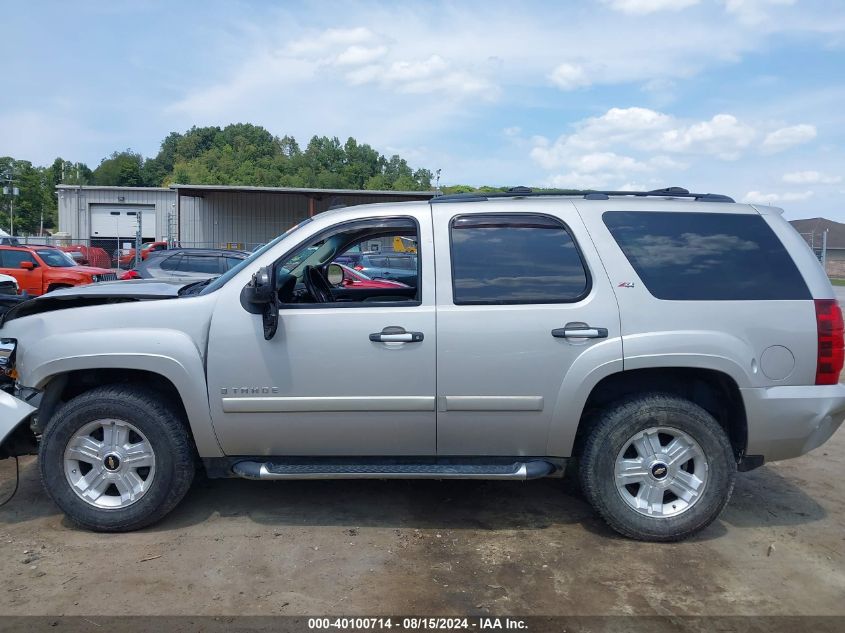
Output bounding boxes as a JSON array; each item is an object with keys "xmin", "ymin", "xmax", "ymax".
[{"xmin": 0, "ymin": 0, "xmax": 845, "ymax": 221}]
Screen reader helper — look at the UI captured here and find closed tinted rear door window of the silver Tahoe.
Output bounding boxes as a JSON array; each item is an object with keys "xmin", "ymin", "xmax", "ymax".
[{"xmin": 450, "ymin": 214, "xmax": 590, "ymax": 305}]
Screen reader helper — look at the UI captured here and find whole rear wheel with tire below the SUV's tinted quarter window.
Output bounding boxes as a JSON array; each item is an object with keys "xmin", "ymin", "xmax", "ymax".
[{"xmin": 579, "ymin": 394, "xmax": 736, "ymax": 541}]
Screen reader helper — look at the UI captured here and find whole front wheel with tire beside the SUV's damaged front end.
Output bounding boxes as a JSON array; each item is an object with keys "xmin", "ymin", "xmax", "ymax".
[{"xmin": 39, "ymin": 385, "xmax": 194, "ymax": 532}]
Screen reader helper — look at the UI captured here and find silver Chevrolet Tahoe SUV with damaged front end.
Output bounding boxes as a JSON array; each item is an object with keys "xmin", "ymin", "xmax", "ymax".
[{"xmin": 0, "ymin": 188, "xmax": 845, "ymax": 541}]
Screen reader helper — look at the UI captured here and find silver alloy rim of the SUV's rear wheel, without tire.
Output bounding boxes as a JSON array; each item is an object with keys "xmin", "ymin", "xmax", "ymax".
[{"xmin": 615, "ymin": 427, "xmax": 707, "ymax": 518}]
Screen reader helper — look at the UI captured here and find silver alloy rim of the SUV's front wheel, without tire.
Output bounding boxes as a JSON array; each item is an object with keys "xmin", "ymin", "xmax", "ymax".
[{"xmin": 64, "ymin": 420, "xmax": 155, "ymax": 509}]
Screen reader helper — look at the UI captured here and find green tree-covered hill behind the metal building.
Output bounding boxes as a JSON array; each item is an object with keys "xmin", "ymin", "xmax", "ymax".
[{"xmin": 0, "ymin": 123, "xmax": 432, "ymax": 234}]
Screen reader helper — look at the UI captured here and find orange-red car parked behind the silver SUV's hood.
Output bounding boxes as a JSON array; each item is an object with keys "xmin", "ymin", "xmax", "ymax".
[{"xmin": 0, "ymin": 246, "xmax": 117, "ymax": 296}]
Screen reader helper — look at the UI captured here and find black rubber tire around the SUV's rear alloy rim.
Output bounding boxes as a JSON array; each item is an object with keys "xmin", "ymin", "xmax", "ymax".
[{"xmin": 579, "ymin": 393, "xmax": 736, "ymax": 541}]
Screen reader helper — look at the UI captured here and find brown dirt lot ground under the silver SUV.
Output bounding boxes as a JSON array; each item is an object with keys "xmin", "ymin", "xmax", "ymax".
[{"xmin": 0, "ymin": 430, "xmax": 845, "ymax": 615}]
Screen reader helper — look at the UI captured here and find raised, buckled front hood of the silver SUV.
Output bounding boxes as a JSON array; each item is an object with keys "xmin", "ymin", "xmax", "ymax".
[{"xmin": 0, "ymin": 279, "xmax": 190, "ymax": 327}]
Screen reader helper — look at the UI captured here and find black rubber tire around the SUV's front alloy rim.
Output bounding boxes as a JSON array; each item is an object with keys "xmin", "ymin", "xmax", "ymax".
[{"xmin": 38, "ymin": 385, "xmax": 194, "ymax": 532}]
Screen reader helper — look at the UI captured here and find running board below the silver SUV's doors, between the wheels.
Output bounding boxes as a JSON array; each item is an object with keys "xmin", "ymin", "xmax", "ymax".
[{"xmin": 232, "ymin": 460, "xmax": 556, "ymax": 479}]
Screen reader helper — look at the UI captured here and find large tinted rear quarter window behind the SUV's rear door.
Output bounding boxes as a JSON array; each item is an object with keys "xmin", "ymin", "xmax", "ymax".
[{"xmin": 602, "ymin": 211, "xmax": 811, "ymax": 301}]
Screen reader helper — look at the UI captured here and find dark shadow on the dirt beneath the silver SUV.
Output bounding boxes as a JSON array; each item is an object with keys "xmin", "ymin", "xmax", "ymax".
[{"xmin": 0, "ymin": 458, "xmax": 827, "ymax": 540}]
